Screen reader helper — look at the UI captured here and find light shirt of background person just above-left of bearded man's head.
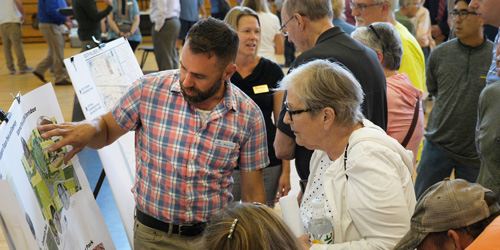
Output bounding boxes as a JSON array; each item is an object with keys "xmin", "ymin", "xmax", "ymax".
[{"xmin": 149, "ymin": 0, "xmax": 181, "ymax": 32}]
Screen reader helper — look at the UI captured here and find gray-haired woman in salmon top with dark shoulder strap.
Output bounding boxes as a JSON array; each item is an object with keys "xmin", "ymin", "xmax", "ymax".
[{"xmin": 352, "ymin": 22, "xmax": 424, "ymax": 164}]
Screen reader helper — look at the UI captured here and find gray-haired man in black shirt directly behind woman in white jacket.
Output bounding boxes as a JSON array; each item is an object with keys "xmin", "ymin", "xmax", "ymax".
[{"xmin": 274, "ymin": 0, "xmax": 387, "ymax": 198}]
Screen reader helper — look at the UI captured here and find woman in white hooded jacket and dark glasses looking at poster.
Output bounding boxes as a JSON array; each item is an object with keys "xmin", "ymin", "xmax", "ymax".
[{"xmin": 280, "ymin": 60, "xmax": 416, "ymax": 249}]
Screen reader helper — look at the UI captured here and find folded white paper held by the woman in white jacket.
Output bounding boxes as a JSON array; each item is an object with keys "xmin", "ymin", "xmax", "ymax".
[{"xmin": 279, "ymin": 195, "xmax": 305, "ymax": 238}]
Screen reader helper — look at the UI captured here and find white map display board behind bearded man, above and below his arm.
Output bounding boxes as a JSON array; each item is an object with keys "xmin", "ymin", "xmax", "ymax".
[{"xmin": 64, "ymin": 38, "xmax": 143, "ymax": 246}]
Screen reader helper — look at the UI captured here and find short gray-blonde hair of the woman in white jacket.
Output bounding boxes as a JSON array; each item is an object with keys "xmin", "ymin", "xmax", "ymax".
[{"xmin": 279, "ymin": 59, "xmax": 364, "ymax": 126}]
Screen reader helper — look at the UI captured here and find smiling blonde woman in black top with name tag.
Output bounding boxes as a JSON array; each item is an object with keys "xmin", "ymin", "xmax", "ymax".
[{"xmin": 224, "ymin": 7, "xmax": 291, "ymax": 207}]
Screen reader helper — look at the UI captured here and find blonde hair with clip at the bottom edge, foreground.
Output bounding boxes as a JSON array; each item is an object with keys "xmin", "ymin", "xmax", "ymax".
[{"xmin": 200, "ymin": 203, "xmax": 301, "ymax": 250}]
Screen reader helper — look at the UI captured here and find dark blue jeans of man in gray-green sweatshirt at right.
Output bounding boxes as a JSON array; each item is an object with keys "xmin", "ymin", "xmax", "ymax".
[{"xmin": 415, "ymin": 140, "xmax": 479, "ymax": 199}]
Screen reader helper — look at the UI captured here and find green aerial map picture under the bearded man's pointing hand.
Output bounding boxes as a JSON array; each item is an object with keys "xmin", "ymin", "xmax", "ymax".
[{"xmin": 20, "ymin": 116, "xmax": 82, "ymax": 249}]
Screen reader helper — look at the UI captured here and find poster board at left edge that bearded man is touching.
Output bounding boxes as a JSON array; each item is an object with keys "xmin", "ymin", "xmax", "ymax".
[{"xmin": 0, "ymin": 83, "xmax": 115, "ymax": 250}]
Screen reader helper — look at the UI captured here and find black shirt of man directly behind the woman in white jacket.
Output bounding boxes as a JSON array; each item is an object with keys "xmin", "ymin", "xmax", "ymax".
[{"xmin": 277, "ymin": 27, "xmax": 387, "ymax": 180}]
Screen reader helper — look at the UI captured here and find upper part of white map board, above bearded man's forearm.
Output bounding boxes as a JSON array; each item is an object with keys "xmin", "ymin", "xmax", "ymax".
[{"xmin": 64, "ymin": 38, "xmax": 143, "ymax": 119}]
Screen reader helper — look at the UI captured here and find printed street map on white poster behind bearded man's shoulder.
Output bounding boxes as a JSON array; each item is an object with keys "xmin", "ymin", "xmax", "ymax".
[{"xmin": 86, "ymin": 44, "xmax": 142, "ymax": 110}]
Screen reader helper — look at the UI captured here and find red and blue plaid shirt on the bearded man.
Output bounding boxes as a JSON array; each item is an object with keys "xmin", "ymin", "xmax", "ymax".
[{"xmin": 113, "ymin": 70, "xmax": 269, "ymax": 224}]
